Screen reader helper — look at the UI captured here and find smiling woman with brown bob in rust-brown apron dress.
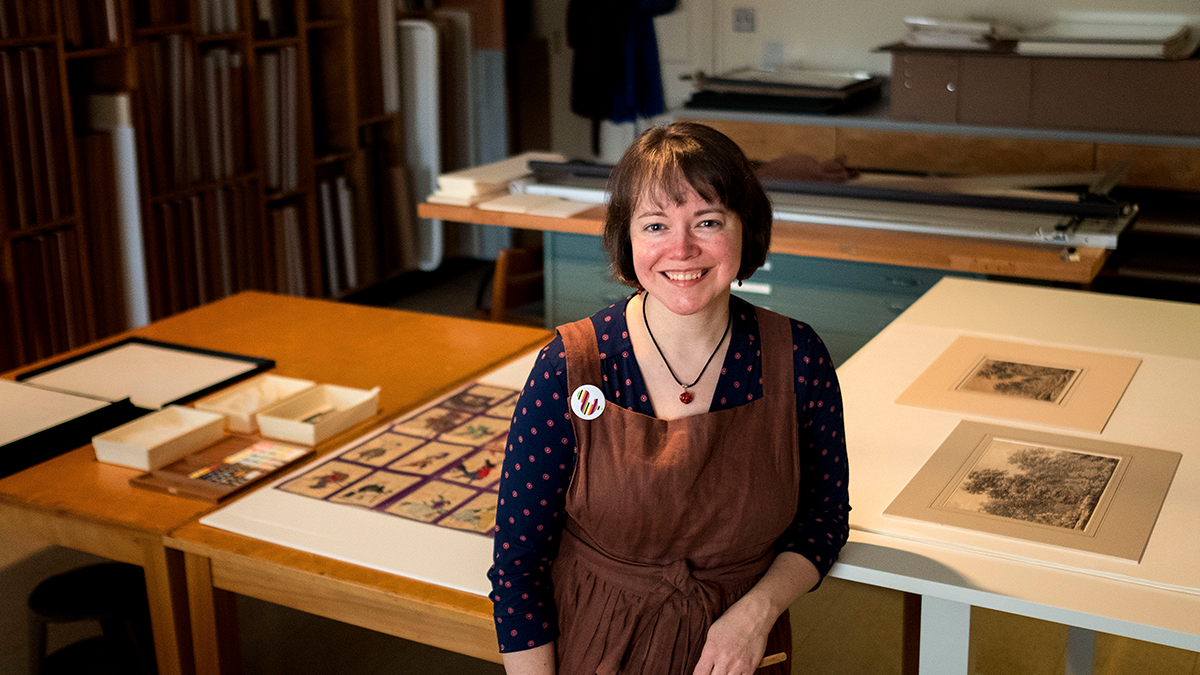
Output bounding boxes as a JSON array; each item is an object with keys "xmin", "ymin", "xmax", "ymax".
[{"xmin": 488, "ymin": 123, "xmax": 850, "ymax": 675}]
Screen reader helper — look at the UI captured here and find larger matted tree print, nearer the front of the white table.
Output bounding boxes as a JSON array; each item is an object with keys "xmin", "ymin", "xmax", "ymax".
[{"xmin": 883, "ymin": 422, "xmax": 1181, "ymax": 561}]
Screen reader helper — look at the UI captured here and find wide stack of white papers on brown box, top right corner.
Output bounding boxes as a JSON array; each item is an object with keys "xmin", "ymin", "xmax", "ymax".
[{"xmin": 1016, "ymin": 20, "xmax": 1200, "ymax": 59}]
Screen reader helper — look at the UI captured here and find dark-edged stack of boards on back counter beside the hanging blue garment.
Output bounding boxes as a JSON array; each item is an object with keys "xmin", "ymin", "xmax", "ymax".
[{"xmin": 685, "ymin": 68, "xmax": 883, "ymax": 114}]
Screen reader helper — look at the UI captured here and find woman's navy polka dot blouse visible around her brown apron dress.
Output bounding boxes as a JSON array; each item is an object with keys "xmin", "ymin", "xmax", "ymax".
[{"xmin": 488, "ymin": 298, "xmax": 850, "ymax": 652}]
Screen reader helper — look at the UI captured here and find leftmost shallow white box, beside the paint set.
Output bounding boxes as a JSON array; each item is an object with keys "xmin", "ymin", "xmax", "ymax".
[{"xmin": 91, "ymin": 406, "xmax": 224, "ymax": 471}]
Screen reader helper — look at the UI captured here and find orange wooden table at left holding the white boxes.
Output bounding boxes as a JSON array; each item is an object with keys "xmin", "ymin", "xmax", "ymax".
[{"xmin": 0, "ymin": 292, "xmax": 551, "ymax": 675}]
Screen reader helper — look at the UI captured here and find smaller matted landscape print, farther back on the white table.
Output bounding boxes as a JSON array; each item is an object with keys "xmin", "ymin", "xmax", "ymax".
[{"xmin": 895, "ymin": 335, "xmax": 1141, "ymax": 434}]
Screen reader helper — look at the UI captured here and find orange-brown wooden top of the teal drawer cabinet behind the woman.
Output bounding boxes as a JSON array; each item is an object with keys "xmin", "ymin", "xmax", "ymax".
[{"xmin": 418, "ymin": 203, "xmax": 1111, "ymax": 285}]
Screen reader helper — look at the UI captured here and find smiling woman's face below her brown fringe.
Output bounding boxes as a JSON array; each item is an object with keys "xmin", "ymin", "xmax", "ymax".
[{"xmin": 629, "ymin": 187, "xmax": 742, "ymax": 316}]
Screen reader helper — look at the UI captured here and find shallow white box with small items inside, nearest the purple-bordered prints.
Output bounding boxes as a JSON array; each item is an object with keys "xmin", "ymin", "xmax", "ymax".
[{"xmin": 254, "ymin": 384, "xmax": 379, "ymax": 446}]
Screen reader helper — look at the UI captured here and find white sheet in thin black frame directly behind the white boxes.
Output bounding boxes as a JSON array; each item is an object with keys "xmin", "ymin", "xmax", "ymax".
[{"xmin": 24, "ymin": 342, "xmax": 257, "ymax": 410}]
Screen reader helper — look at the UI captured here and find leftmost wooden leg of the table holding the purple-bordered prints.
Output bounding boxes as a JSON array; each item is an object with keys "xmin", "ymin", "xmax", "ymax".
[{"xmin": 184, "ymin": 554, "xmax": 241, "ymax": 675}]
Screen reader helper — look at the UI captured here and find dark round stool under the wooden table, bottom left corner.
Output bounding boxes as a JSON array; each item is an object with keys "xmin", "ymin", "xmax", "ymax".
[{"xmin": 28, "ymin": 562, "xmax": 157, "ymax": 675}]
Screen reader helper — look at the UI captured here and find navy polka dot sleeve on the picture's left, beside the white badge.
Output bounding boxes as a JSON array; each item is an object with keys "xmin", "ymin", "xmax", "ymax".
[{"xmin": 487, "ymin": 338, "xmax": 575, "ymax": 652}]
